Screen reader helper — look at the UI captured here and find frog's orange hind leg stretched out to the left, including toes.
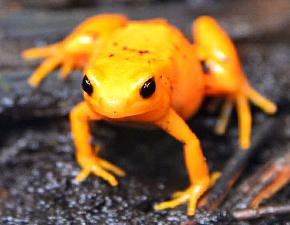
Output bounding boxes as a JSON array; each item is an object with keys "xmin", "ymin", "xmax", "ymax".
[{"xmin": 22, "ymin": 14, "xmax": 127, "ymax": 87}]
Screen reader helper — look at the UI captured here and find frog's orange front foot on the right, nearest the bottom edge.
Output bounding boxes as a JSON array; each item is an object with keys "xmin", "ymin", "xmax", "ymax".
[{"xmin": 154, "ymin": 182, "xmax": 209, "ymax": 216}]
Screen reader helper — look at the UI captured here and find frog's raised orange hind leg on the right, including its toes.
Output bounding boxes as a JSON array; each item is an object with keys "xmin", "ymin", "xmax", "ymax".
[{"xmin": 193, "ymin": 16, "xmax": 277, "ymax": 149}]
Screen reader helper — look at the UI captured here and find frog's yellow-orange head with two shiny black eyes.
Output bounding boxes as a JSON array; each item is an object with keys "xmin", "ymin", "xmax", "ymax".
[{"xmin": 82, "ymin": 58, "xmax": 169, "ymax": 118}]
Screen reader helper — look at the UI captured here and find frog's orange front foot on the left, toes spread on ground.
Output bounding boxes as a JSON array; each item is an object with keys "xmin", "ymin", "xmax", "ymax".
[{"xmin": 75, "ymin": 157, "xmax": 125, "ymax": 186}]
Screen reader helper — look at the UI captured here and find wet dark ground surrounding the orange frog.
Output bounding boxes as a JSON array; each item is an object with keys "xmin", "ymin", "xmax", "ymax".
[{"xmin": 0, "ymin": 0, "xmax": 290, "ymax": 225}]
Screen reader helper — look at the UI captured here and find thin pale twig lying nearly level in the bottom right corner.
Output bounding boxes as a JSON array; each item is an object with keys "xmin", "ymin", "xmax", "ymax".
[{"xmin": 233, "ymin": 204, "xmax": 290, "ymax": 220}]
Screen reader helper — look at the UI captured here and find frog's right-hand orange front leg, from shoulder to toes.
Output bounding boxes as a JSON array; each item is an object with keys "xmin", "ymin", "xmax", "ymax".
[{"xmin": 155, "ymin": 109, "xmax": 210, "ymax": 215}]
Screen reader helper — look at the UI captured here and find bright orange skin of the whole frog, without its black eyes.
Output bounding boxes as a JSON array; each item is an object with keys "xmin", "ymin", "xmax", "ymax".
[{"xmin": 23, "ymin": 14, "xmax": 276, "ymax": 215}]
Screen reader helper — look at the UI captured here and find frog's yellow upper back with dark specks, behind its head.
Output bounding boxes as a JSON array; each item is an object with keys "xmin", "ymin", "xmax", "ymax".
[{"xmin": 100, "ymin": 19, "xmax": 177, "ymax": 60}]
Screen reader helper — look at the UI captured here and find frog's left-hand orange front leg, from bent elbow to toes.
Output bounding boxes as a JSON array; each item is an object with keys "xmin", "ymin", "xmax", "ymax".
[{"xmin": 70, "ymin": 102, "xmax": 125, "ymax": 186}]
